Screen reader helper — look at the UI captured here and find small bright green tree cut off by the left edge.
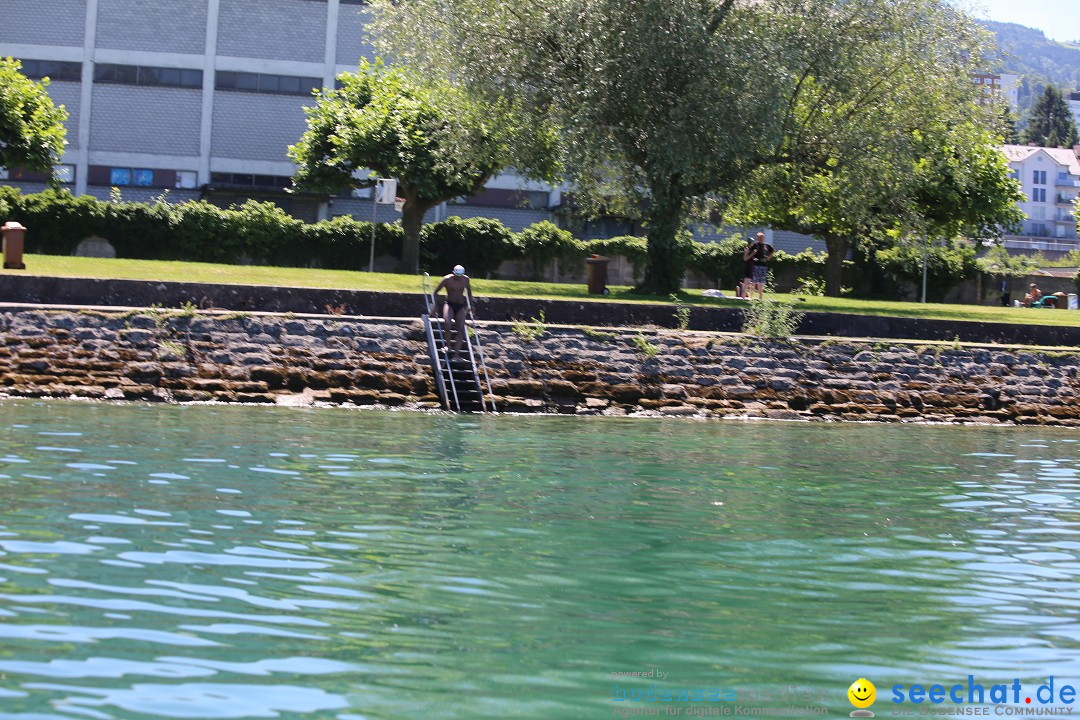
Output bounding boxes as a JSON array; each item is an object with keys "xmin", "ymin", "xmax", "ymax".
[{"xmin": 0, "ymin": 57, "xmax": 67, "ymax": 174}]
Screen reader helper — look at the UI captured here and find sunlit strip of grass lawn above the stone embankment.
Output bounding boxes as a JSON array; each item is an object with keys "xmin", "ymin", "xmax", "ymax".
[{"xmin": 6, "ymin": 255, "xmax": 1080, "ymax": 326}]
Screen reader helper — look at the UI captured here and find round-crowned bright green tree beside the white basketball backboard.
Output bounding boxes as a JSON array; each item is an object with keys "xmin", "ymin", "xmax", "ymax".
[{"xmin": 288, "ymin": 59, "xmax": 522, "ymax": 273}]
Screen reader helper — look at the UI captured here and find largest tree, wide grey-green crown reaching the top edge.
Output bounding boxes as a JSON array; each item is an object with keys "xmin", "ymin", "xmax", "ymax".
[{"xmin": 373, "ymin": 0, "xmax": 981, "ymax": 293}]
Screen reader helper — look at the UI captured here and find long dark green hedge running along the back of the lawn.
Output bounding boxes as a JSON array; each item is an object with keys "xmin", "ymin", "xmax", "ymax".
[{"xmin": 0, "ymin": 186, "xmax": 824, "ymax": 287}]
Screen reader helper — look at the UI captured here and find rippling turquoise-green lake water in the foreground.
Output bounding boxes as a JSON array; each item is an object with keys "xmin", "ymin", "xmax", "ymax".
[{"xmin": 0, "ymin": 400, "xmax": 1080, "ymax": 720}]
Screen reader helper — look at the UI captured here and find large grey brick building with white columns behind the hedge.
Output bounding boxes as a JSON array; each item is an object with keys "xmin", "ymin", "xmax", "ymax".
[{"xmin": 0, "ymin": 0, "xmax": 823, "ymax": 253}]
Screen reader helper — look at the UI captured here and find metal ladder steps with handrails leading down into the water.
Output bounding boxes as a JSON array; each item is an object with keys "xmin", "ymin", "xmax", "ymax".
[{"xmin": 420, "ymin": 273, "xmax": 495, "ymax": 412}]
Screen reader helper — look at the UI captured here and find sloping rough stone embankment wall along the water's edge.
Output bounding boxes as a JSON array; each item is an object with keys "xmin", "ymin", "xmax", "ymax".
[{"xmin": 0, "ymin": 308, "xmax": 1080, "ymax": 426}]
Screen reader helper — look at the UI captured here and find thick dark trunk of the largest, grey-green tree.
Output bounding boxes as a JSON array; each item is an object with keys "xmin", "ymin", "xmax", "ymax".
[{"xmin": 642, "ymin": 178, "xmax": 686, "ymax": 295}]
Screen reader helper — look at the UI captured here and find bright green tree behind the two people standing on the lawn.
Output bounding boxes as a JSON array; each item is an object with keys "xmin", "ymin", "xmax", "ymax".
[{"xmin": 729, "ymin": 110, "xmax": 1024, "ymax": 297}]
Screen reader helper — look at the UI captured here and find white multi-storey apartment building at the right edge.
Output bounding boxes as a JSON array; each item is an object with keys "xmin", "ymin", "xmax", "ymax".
[{"xmin": 1003, "ymin": 145, "xmax": 1080, "ymax": 250}]
